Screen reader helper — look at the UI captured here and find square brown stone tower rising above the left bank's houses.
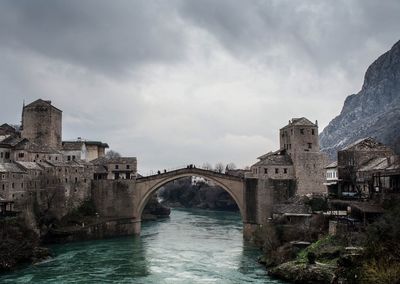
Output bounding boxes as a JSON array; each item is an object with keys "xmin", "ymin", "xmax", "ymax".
[{"xmin": 21, "ymin": 99, "xmax": 62, "ymax": 149}]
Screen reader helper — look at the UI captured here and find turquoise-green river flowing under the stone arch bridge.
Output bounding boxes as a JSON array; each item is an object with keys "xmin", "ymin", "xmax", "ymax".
[{"xmin": 0, "ymin": 209, "xmax": 282, "ymax": 283}]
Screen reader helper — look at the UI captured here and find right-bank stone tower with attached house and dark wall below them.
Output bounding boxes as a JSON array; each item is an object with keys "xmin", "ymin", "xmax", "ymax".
[{"xmin": 245, "ymin": 117, "xmax": 326, "ymax": 224}]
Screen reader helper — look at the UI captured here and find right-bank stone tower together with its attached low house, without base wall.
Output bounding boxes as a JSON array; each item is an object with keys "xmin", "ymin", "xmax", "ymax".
[{"xmin": 251, "ymin": 117, "xmax": 327, "ymax": 195}]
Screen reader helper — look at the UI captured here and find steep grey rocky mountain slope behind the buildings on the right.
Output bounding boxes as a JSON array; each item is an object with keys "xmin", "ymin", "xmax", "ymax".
[{"xmin": 320, "ymin": 41, "xmax": 400, "ymax": 159}]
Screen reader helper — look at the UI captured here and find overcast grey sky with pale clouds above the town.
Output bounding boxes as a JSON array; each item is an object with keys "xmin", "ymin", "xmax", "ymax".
[{"xmin": 0, "ymin": 0, "xmax": 400, "ymax": 173}]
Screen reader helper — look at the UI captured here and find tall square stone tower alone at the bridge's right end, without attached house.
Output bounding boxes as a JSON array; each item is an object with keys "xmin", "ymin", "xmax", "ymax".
[{"xmin": 279, "ymin": 117, "xmax": 327, "ymax": 195}]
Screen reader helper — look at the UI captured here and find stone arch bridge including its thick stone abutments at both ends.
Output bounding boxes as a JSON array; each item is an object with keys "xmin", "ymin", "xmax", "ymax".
[{"xmin": 92, "ymin": 167, "xmax": 259, "ymax": 235}]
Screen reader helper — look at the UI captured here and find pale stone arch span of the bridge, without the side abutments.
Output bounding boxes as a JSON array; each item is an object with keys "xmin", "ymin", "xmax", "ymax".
[{"xmin": 134, "ymin": 168, "xmax": 245, "ymax": 221}]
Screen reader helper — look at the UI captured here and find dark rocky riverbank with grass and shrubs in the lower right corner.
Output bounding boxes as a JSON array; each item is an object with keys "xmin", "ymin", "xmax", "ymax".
[{"xmin": 260, "ymin": 204, "xmax": 400, "ymax": 284}]
